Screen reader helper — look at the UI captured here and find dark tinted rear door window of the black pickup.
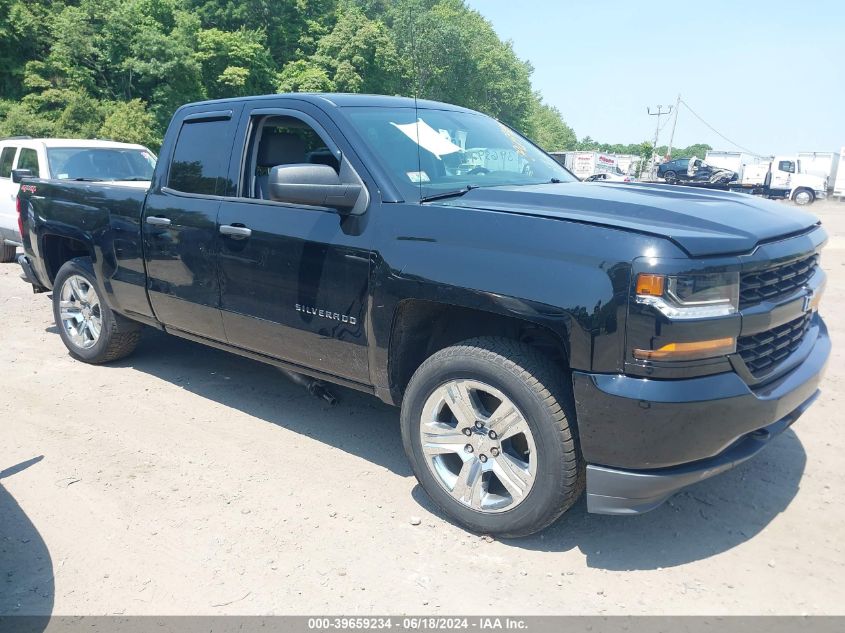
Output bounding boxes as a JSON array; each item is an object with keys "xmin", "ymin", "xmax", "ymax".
[{"xmin": 167, "ymin": 119, "xmax": 232, "ymax": 195}]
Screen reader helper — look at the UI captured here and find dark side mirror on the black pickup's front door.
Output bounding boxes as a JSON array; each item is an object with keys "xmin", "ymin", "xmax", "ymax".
[{"xmin": 268, "ymin": 163, "xmax": 361, "ymax": 211}]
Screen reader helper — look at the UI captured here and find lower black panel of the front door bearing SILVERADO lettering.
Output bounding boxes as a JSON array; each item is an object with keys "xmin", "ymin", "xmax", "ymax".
[{"xmin": 218, "ymin": 200, "xmax": 369, "ymax": 382}]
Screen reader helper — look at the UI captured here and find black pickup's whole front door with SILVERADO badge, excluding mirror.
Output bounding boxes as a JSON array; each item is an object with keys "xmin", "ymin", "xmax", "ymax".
[{"xmin": 218, "ymin": 101, "xmax": 370, "ymax": 383}]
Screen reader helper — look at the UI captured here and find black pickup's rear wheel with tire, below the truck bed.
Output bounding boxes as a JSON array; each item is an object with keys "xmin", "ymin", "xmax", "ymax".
[{"xmin": 53, "ymin": 257, "xmax": 141, "ymax": 364}]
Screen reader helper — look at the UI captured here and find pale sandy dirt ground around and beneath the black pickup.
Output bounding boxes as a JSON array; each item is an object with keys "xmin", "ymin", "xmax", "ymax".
[{"xmin": 0, "ymin": 202, "xmax": 845, "ymax": 615}]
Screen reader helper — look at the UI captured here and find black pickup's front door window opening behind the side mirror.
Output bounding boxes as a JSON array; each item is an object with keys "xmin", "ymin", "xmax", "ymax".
[{"xmin": 245, "ymin": 116, "xmax": 340, "ymax": 200}]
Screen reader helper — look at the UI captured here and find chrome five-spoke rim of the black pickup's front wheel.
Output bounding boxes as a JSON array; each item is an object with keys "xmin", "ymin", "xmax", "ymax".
[{"xmin": 420, "ymin": 380, "xmax": 537, "ymax": 513}]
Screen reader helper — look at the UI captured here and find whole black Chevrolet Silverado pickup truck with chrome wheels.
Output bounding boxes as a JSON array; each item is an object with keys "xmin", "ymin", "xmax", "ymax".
[{"xmin": 18, "ymin": 94, "xmax": 830, "ymax": 536}]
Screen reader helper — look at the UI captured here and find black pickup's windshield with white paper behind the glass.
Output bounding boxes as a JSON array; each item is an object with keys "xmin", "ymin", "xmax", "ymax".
[{"xmin": 345, "ymin": 107, "xmax": 576, "ymax": 200}]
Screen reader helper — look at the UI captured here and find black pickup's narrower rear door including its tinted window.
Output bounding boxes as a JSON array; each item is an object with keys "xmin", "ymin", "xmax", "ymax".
[{"xmin": 143, "ymin": 104, "xmax": 242, "ymax": 341}]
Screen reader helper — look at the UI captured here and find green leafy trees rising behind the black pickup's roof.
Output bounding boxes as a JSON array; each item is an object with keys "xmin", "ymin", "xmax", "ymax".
[{"xmin": 0, "ymin": 0, "xmax": 708, "ymax": 160}]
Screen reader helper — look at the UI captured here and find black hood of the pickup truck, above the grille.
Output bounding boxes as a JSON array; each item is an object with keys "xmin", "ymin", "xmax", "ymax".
[{"xmin": 439, "ymin": 182, "xmax": 818, "ymax": 257}]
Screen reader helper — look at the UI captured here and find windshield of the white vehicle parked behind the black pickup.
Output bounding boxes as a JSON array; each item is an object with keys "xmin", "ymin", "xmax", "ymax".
[{"xmin": 47, "ymin": 147, "xmax": 156, "ymax": 180}]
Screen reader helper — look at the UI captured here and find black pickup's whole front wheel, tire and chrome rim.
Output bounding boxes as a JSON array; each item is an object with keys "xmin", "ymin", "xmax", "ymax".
[{"xmin": 401, "ymin": 338, "xmax": 584, "ymax": 537}]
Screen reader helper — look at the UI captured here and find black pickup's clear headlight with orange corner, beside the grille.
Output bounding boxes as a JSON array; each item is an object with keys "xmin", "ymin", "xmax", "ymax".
[{"xmin": 637, "ymin": 272, "xmax": 739, "ymax": 319}]
